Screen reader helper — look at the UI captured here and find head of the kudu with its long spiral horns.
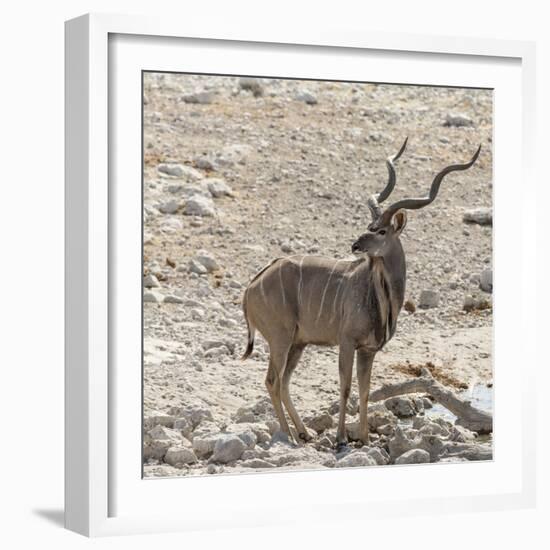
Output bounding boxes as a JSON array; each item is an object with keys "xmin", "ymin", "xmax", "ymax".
[{"xmin": 351, "ymin": 138, "xmax": 481, "ymax": 257}]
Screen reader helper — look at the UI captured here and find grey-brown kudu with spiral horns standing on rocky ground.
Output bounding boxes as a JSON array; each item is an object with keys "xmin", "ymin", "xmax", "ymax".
[{"xmin": 242, "ymin": 138, "xmax": 481, "ymax": 449}]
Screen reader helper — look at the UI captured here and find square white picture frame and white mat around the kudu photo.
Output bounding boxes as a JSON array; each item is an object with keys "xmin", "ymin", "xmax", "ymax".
[{"xmin": 65, "ymin": 15, "xmax": 536, "ymax": 536}]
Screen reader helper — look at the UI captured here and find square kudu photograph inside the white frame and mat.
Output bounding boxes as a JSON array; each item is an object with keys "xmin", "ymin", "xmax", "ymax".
[{"xmin": 142, "ymin": 72, "xmax": 493, "ymax": 478}]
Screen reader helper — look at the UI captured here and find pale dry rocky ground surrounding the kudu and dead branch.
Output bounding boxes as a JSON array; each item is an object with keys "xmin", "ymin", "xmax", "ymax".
[{"xmin": 143, "ymin": 73, "xmax": 492, "ymax": 477}]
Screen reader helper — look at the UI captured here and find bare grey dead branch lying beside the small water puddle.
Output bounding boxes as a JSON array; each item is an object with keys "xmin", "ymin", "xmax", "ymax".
[{"xmin": 369, "ymin": 368, "xmax": 493, "ymax": 434}]
